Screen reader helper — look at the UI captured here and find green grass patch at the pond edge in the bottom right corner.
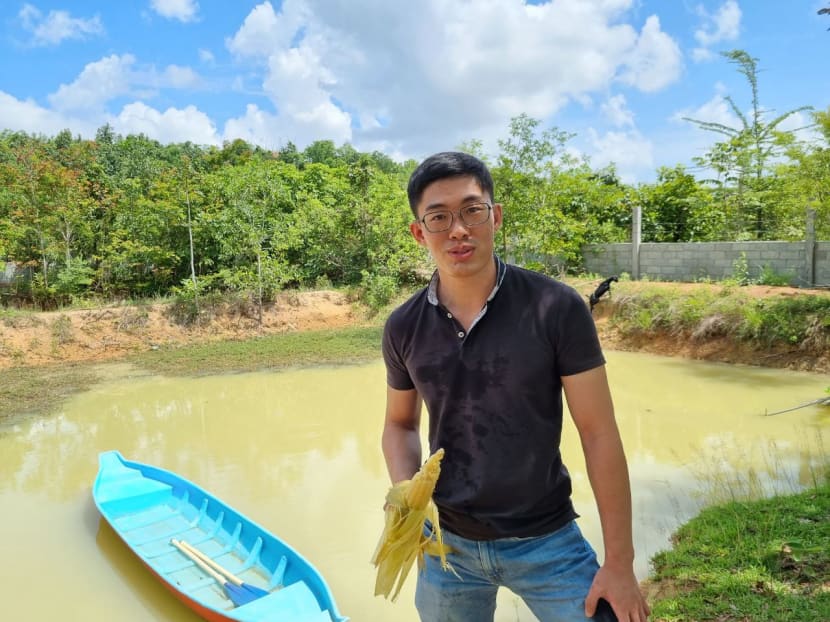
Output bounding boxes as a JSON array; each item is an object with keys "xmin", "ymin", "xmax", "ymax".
[{"xmin": 652, "ymin": 483, "xmax": 830, "ymax": 622}]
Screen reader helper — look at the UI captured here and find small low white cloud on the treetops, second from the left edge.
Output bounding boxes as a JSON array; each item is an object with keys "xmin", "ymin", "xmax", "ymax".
[{"xmin": 110, "ymin": 102, "xmax": 221, "ymax": 145}]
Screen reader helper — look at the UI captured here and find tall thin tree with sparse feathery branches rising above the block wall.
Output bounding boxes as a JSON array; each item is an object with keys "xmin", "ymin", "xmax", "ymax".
[{"xmin": 685, "ymin": 50, "xmax": 810, "ymax": 239}]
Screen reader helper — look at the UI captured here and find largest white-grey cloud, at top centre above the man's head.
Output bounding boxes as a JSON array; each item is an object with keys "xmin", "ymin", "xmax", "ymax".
[{"xmin": 226, "ymin": 0, "xmax": 681, "ymax": 157}]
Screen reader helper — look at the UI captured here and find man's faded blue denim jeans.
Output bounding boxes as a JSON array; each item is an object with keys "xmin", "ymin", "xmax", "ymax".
[{"xmin": 415, "ymin": 521, "xmax": 599, "ymax": 622}]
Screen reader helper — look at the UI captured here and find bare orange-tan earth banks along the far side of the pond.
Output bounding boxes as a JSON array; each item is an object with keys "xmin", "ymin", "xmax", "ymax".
[{"xmin": 0, "ymin": 282, "xmax": 830, "ymax": 372}]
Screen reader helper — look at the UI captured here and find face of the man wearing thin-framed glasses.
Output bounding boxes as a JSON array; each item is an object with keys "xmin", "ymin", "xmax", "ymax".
[{"xmin": 409, "ymin": 177, "xmax": 502, "ymax": 277}]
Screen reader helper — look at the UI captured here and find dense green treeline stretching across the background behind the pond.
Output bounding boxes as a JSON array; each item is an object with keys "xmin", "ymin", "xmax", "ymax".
[{"xmin": 0, "ymin": 49, "xmax": 830, "ymax": 312}]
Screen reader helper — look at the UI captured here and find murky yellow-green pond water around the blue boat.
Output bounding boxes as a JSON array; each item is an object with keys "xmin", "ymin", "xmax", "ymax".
[{"xmin": 0, "ymin": 352, "xmax": 830, "ymax": 622}]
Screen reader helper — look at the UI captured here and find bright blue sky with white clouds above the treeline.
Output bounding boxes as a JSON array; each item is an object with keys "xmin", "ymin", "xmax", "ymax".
[{"xmin": 0, "ymin": 0, "xmax": 830, "ymax": 183}]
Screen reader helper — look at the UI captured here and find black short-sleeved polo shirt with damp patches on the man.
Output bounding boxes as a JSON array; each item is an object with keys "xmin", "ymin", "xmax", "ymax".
[{"xmin": 383, "ymin": 258, "xmax": 605, "ymax": 540}]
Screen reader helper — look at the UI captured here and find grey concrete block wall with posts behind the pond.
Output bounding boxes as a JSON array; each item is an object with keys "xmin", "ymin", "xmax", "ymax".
[{"xmin": 583, "ymin": 242, "xmax": 830, "ymax": 287}]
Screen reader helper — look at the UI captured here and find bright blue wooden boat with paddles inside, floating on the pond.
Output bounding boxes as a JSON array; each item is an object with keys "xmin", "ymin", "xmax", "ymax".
[{"xmin": 92, "ymin": 451, "xmax": 348, "ymax": 622}]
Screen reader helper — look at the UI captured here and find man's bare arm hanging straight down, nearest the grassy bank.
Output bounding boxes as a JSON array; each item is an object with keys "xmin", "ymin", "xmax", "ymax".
[{"xmin": 562, "ymin": 366, "xmax": 649, "ymax": 622}]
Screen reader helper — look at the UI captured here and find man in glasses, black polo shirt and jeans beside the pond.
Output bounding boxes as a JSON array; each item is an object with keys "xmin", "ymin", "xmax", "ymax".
[{"xmin": 382, "ymin": 152, "xmax": 649, "ymax": 622}]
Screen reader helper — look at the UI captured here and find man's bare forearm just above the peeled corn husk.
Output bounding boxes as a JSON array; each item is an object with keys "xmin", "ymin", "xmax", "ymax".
[{"xmin": 381, "ymin": 387, "xmax": 421, "ymax": 484}]
